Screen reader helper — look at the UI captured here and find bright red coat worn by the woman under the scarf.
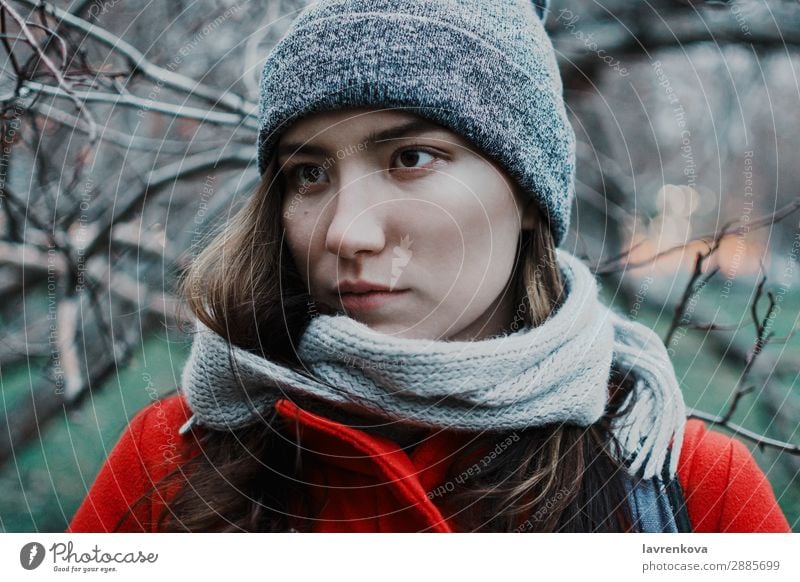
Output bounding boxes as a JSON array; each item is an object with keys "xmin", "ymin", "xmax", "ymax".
[{"xmin": 67, "ymin": 394, "xmax": 791, "ymax": 533}]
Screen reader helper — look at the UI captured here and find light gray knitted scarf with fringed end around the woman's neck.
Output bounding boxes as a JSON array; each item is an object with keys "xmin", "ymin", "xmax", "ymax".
[{"xmin": 181, "ymin": 250, "xmax": 686, "ymax": 479}]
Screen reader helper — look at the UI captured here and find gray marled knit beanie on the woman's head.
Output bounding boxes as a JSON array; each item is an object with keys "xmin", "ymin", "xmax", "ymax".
[{"xmin": 258, "ymin": 0, "xmax": 575, "ymax": 244}]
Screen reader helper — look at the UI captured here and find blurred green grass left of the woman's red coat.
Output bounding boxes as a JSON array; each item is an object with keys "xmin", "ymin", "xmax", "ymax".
[{"xmin": 0, "ymin": 334, "xmax": 188, "ymax": 532}]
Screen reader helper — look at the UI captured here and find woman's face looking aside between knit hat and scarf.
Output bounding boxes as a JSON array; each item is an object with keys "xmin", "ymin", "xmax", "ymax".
[{"xmin": 277, "ymin": 109, "xmax": 533, "ymax": 341}]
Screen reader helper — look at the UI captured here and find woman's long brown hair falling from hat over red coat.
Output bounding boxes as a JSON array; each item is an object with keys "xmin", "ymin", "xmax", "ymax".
[{"xmin": 118, "ymin": 159, "xmax": 632, "ymax": 532}]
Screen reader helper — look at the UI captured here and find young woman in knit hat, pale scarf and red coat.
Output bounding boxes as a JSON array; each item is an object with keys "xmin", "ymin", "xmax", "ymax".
[{"xmin": 68, "ymin": 0, "xmax": 789, "ymax": 532}]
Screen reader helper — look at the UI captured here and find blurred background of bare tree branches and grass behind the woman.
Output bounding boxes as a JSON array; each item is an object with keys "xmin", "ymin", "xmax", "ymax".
[{"xmin": 0, "ymin": 0, "xmax": 800, "ymax": 532}]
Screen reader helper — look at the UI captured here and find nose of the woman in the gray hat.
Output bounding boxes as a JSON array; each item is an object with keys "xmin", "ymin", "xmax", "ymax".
[{"xmin": 325, "ymin": 177, "xmax": 386, "ymax": 259}]
